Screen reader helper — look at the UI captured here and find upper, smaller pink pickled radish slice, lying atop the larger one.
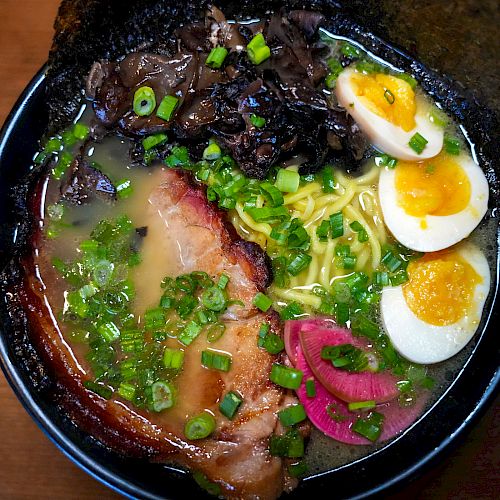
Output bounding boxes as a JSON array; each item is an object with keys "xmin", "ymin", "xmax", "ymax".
[{"xmin": 299, "ymin": 326, "xmax": 399, "ymax": 403}]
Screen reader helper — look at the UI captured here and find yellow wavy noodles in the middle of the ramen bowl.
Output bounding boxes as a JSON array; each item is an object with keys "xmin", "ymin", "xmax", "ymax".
[{"xmin": 231, "ymin": 166, "xmax": 387, "ymax": 296}]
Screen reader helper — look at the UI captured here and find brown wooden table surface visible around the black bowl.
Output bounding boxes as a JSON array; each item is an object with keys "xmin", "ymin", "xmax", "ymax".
[{"xmin": 0, "ymin": 0, "xmax": 500, "ymax": 500}]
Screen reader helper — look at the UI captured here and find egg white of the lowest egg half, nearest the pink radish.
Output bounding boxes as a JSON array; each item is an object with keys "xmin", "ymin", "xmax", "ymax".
[{"xmin": 380, "ymin": 243, "xmax": 490, "ymax": 364}]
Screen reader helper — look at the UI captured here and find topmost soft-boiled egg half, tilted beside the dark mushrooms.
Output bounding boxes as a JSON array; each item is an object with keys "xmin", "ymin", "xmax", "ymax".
[{"xmin": 336, "ymin": 68, "xmax": 443, "ymax": 161}]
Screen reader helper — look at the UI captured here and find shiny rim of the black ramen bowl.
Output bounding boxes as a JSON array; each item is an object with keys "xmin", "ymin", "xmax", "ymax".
[{"xmin": 0, "ymin": 64, "xmax": 500, "ymax": 499}]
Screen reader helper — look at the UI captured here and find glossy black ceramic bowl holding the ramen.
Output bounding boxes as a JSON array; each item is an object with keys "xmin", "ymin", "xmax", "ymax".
[{"xmin": 0, "ymin": 4, "xmax": 500, "ymax": 499}]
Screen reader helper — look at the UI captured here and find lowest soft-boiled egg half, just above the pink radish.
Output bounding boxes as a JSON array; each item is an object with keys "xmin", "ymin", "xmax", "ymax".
[{"xmin": 381, "ymin": 242, "xmax": 490, "ymax": 363}]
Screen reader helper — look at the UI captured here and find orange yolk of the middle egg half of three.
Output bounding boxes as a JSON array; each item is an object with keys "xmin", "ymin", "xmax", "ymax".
[{"xmin": 395, "ymin": 153, "xmax": 471, "ymax": 217}]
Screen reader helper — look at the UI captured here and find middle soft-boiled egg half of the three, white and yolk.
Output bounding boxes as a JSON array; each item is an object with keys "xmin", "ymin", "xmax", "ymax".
[{"xmin": 379, "ymin": 152, "xmax": 489, "ymax": 252}]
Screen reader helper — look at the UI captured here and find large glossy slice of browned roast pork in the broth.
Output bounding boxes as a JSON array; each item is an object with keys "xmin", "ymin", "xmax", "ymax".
[{"xmin": 18, "ymin": 170, "xmax": 297, "ymax": 499}]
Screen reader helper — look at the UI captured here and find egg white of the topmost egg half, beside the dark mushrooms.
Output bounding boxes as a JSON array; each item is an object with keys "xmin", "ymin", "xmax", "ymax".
[{"xmin": 335, "ymin": 69, "xmax": 444, "ymax": 161}]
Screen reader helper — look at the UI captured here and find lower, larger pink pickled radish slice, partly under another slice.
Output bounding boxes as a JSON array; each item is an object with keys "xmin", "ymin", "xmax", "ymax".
[{"xmin": 296, "ymin": 348, "xmax": 427, "ymax": 445}]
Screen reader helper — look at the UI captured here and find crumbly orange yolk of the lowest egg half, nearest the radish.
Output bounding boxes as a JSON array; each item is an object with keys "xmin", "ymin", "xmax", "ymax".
[{"xmin": 403, "ymin": 250, "xmax": 482, "ymax": 326}]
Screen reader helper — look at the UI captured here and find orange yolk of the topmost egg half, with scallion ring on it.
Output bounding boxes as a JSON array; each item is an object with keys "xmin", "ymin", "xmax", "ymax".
[{"xmin": 351, "ymin": 73, "xmax": 417, "ymax": 132}]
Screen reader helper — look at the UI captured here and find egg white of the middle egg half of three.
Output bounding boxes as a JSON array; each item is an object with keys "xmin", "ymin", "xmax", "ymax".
[{"xmin": 379, "ymin": 154, "xmax": 489, "ymax": 252}]
